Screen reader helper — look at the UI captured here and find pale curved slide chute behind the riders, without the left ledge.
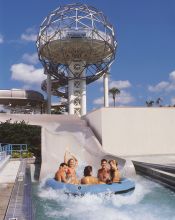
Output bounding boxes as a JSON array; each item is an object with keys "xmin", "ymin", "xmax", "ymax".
[{"xmin": 40, "ymin": 118, "xmax": 132, "ymax": 179}]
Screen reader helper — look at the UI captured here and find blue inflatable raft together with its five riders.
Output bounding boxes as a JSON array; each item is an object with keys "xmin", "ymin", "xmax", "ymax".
[{"xmin": 45, "ymin": 151, "xmax": 135, "ymax": 195}]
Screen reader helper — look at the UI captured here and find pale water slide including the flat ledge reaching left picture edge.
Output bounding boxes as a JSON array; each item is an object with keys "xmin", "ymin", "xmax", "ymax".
[{"xmin": 0, "ymin": 114, "xmax": 135, "ymax": 180}]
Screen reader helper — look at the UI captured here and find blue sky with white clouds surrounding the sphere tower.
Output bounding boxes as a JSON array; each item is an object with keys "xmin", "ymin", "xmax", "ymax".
[{"xmin": 0, "ymin": 0, "xmax": 175, "ymax": 110}]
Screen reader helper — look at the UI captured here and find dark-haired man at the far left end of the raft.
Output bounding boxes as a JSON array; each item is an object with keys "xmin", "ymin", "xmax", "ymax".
[{"xmin": 55, "ymin": 163, "xmax": 68, "ymax": 183}]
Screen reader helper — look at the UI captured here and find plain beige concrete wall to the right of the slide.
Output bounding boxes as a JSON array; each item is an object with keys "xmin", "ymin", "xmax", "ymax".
[{"xmin": 86, "ymin": 107, "xmax": 175, "ymax": 156}]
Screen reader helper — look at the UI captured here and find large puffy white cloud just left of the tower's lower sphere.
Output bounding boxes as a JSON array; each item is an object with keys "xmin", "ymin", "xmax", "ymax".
[{"xmin": 10, "ymin": 63, "xmax": 46, "ymax": 84}]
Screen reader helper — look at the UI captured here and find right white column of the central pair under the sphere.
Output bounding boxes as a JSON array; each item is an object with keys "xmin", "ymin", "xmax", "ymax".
[{"xmin": 81, "ymin": 71, "xmax": 86, "ymax": 116}]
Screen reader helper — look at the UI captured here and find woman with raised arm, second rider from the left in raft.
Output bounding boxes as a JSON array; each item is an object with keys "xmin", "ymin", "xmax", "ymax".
[{"xmin": 64, "ymin": 151, "xmax": 80, "ymax": 184}]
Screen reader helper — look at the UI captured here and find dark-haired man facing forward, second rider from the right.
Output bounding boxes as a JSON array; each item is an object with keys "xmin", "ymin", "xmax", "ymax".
[{"xmin": 97, "ymin": 159, "xmax": 111, "ymax": 183}]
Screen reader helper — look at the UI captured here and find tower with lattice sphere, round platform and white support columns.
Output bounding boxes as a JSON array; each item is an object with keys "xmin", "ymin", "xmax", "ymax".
[{"xmin": 37, "ymin": 3, "xmax": 117, "ymax": 116}]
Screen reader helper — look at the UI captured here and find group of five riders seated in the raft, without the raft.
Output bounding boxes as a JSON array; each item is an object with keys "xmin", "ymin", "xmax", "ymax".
[{"xmin": 54, "ymin": 151, "xmax": 121, "ymax": 185}]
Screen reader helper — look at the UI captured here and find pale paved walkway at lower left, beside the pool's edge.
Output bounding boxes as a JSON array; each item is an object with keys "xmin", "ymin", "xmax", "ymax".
[{"xmin": 0, "ymin": 161, "xmax": 20, "ymax": 220}]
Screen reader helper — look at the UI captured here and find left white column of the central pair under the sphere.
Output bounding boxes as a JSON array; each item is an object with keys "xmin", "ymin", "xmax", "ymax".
[{"xmin": 68, "ymin": 72, "xmax": 74, "ymax": 115}]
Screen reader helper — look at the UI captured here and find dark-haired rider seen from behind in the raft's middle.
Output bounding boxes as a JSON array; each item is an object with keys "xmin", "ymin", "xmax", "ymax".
[{"xmin": 81, "ymin": 166, "xmax": 99, "ymax": 185}]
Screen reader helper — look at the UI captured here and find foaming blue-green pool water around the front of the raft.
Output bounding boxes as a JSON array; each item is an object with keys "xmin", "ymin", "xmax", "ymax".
[{"xmin": 33, "ymin": 176, "xmax": 175, "ymax": 220}]
